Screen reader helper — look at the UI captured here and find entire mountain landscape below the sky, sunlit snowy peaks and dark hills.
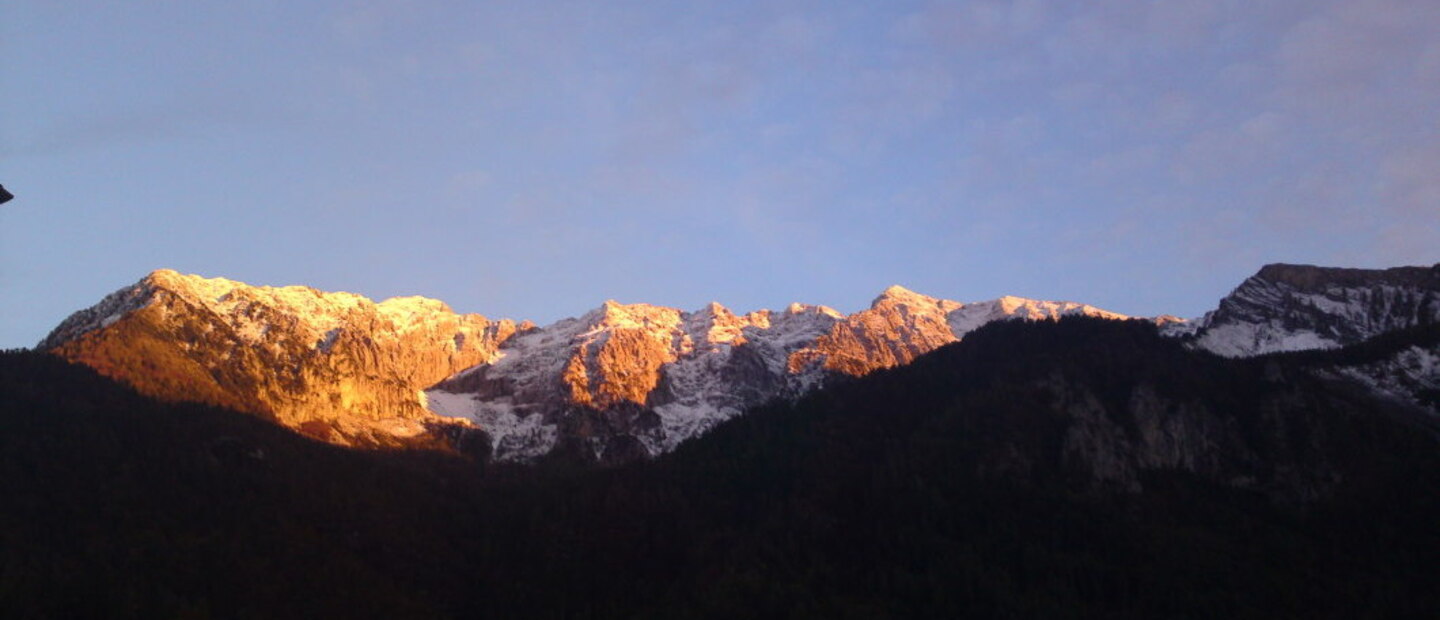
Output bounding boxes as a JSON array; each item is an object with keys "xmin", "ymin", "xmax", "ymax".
[{"xmin": 11, "ymin": 265, "xmax": 1440, "ymax": 619}]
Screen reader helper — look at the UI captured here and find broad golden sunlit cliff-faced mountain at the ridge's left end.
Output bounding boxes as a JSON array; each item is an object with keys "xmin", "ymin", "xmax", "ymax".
[{"xmin": 39, "ymin": 270, "xmax": 516, "ymax": 446}]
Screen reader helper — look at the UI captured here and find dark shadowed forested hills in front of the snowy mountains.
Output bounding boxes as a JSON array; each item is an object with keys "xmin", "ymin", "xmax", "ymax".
[{"xmin": 0, "ymin": 319, "xmax": 1440, "ymax": 619}]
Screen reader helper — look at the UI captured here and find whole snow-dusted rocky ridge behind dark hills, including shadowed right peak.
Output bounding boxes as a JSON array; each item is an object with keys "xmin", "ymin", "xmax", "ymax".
[{"xmin": 37, "ymin": 265, "xmax": 1440, "ymax": 462}]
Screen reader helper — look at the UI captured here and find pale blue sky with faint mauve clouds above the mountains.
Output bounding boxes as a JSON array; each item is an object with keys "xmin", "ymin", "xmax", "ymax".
[{"xmin": 0, "ymin": 0, "xmax": 1440, "ymax": 348}]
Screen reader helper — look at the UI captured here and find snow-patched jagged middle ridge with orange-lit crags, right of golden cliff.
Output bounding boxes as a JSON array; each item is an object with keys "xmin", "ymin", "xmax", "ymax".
[{"xmin": 426, "ymin": 286, "xmax": 1123, "ymax": 462}]
